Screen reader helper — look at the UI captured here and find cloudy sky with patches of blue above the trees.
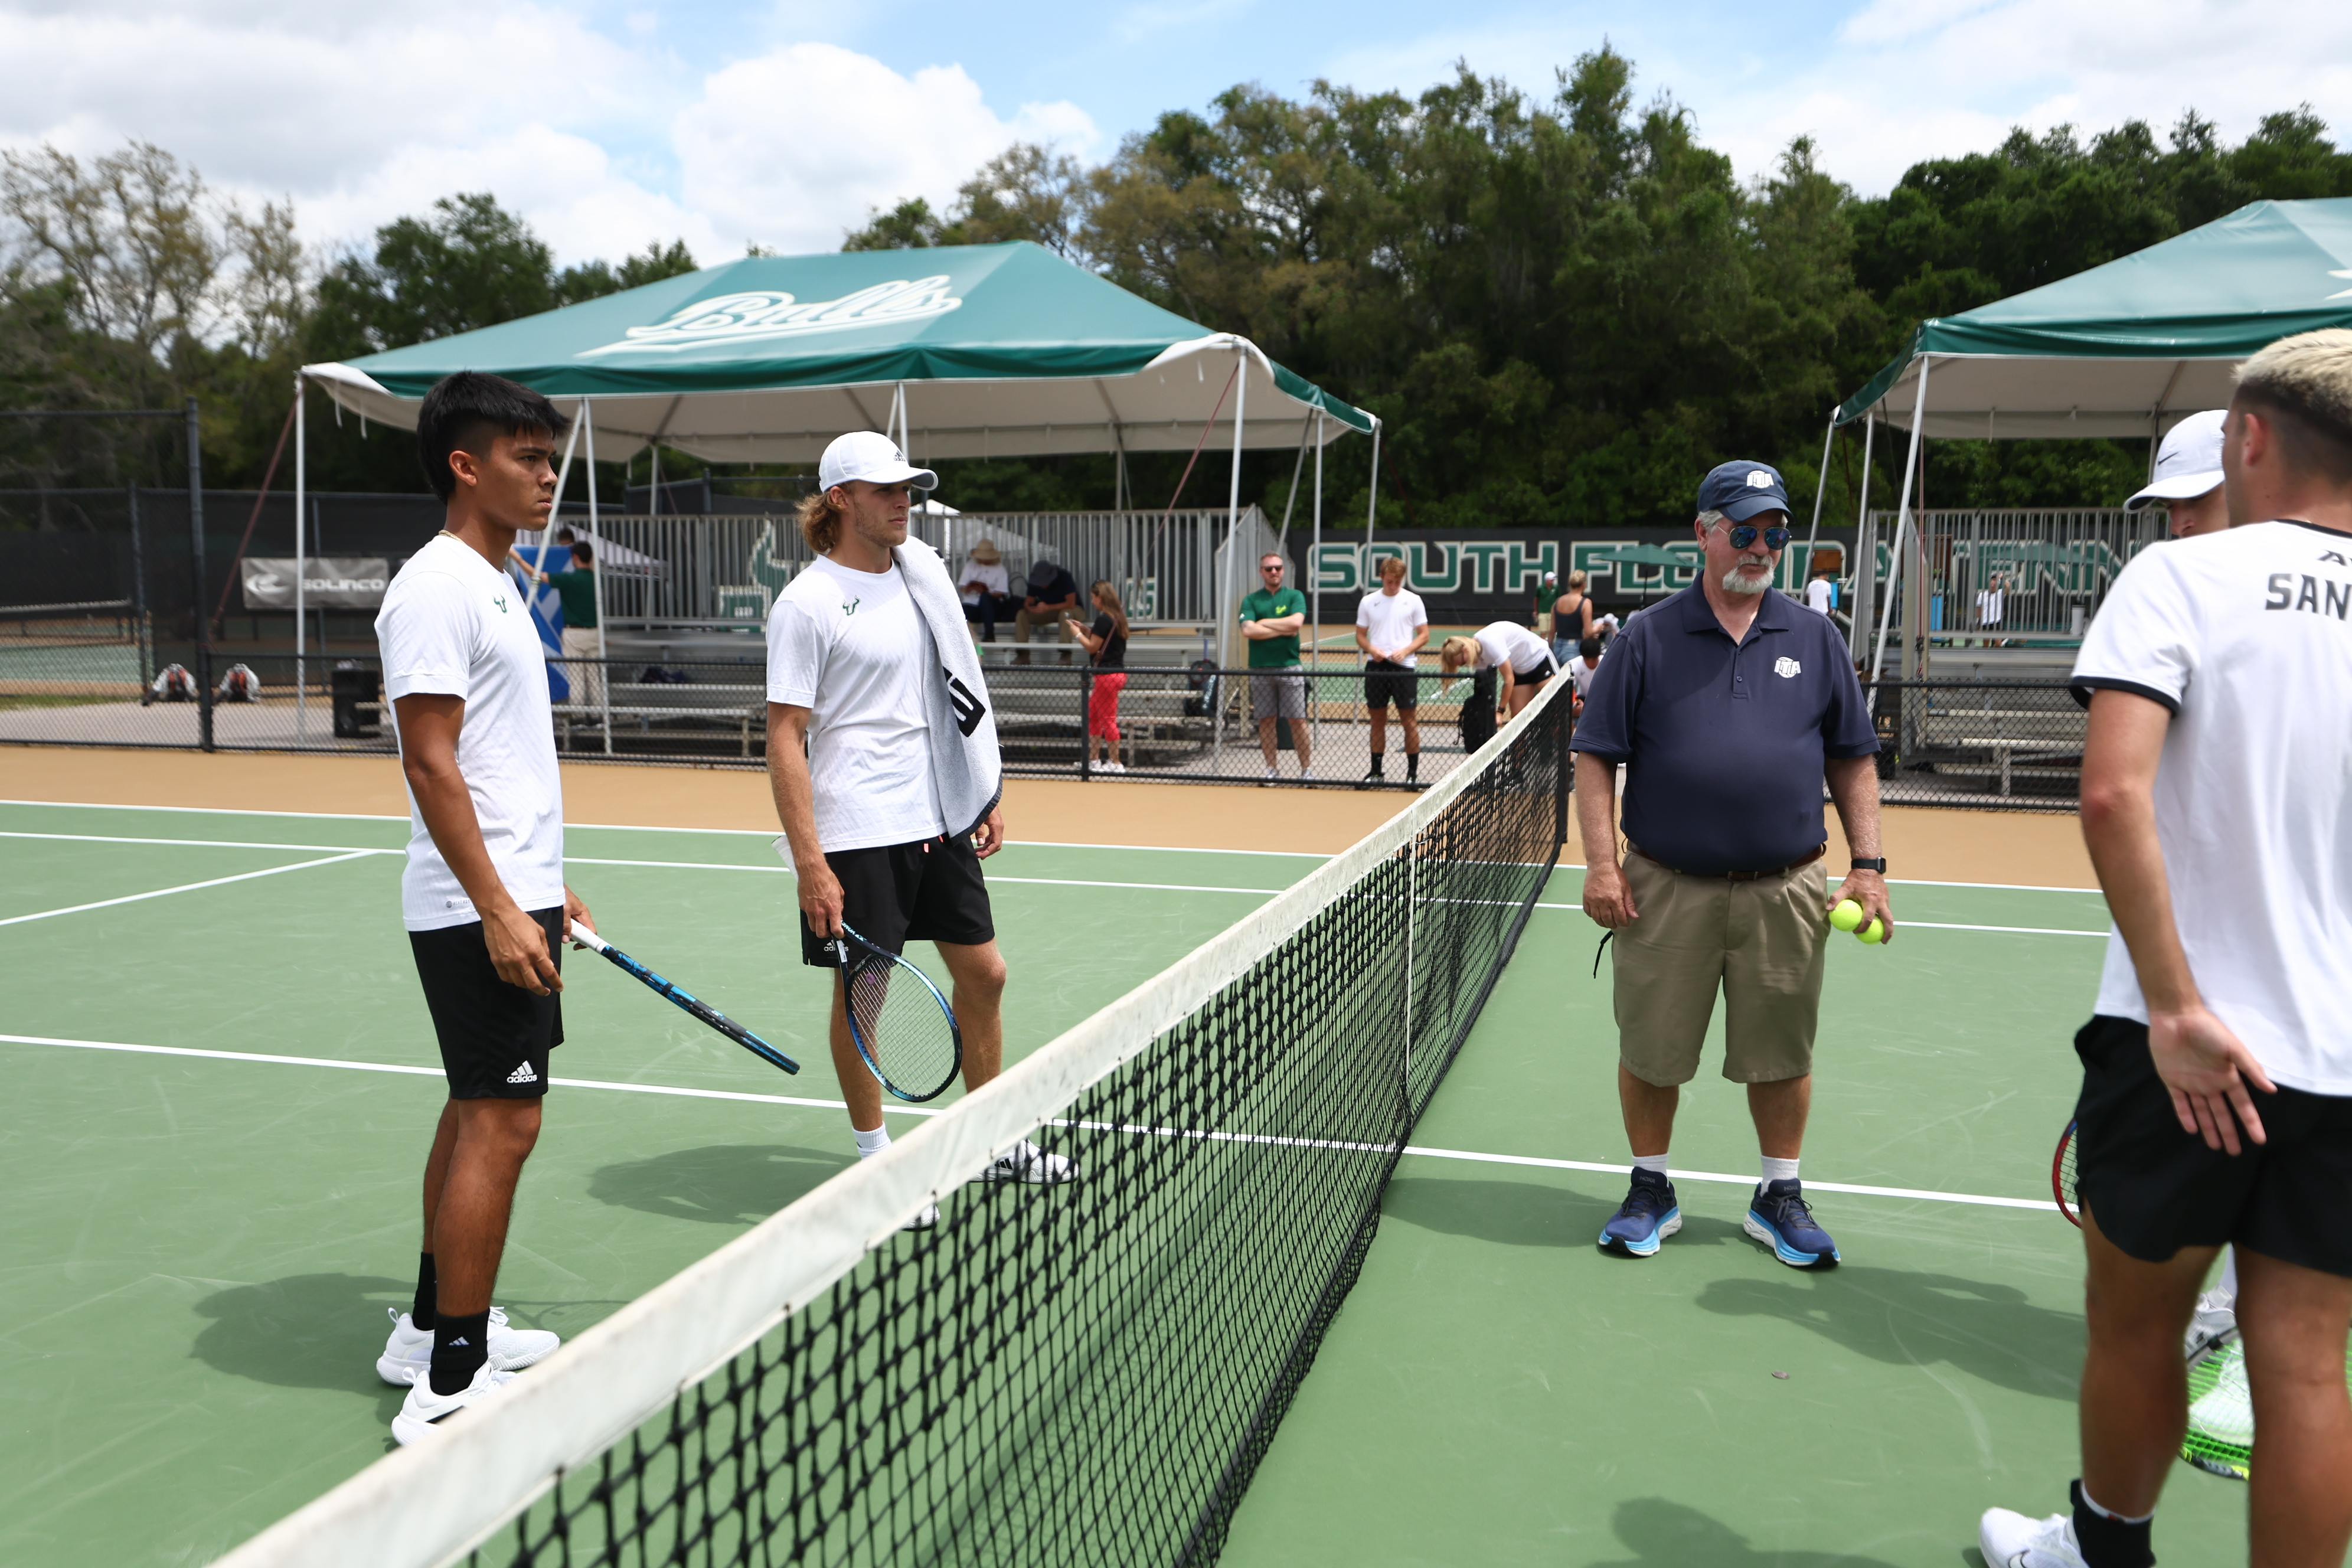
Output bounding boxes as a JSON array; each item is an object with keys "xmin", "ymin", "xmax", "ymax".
[{"xmin": 0, "ymin": 0, "xmax": 2352, "ymax": 261}]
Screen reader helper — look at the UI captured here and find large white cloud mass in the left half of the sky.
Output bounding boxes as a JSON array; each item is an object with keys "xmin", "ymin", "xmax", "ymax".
[{"xmin": 0, "ymin": 0, "xmax": 1096, "ymax": 263}]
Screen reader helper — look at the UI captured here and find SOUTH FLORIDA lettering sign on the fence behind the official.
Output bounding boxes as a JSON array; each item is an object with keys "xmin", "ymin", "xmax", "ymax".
[{"xmin": 1293, "ymin": 529, "xmax": 1846, "ymax": 618}]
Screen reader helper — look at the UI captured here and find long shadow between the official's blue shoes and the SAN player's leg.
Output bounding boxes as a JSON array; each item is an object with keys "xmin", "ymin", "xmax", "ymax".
[{"xmin": 1698, "ymin": 1262, "xmax": 2082, "ymax": 1401}]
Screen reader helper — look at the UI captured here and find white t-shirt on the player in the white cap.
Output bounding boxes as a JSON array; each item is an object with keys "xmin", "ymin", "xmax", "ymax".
[{"xmin": 767, "ymin": 555, "xmax": 948, "ymax": 851}]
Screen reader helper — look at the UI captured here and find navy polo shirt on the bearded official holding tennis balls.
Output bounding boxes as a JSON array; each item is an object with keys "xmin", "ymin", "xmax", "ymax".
[{"xmin": 1569, "ymin": 586, "xmax": 1879, "ymax": 877}]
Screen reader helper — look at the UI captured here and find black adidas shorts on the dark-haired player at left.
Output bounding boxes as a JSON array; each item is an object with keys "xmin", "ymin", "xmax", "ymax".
[{"xmin": 409, "ymin": 905, "xmax": 564, "ymax": 1100}]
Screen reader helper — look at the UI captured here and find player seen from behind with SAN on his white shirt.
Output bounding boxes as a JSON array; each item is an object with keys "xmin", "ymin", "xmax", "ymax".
[{"xmin": 1978, "ymin": 329, "xmax": 2352, "ymax": 1568}]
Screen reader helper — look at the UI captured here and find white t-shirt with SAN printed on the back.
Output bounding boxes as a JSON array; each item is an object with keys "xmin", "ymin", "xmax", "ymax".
[{"xmin": 2075, "ymin": 522, "xmax": 2352, "ymax": 1096}]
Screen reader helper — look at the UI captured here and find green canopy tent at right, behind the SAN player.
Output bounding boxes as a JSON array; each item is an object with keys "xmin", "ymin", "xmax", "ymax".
[{"xmin": 1816, "ymin": 197, "xmax": 2352, "ymax": 670}]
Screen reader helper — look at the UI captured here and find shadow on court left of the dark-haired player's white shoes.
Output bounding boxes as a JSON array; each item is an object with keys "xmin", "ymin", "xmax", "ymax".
[{"xmin": 188, "ymin": 1274, "xmax": 416, "ymax": 1420}]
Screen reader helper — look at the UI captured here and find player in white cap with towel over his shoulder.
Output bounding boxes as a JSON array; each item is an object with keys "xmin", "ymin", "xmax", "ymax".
[{"xmin": 767, "ymin": 430, "xmax": 1077, "ymax": 1225}]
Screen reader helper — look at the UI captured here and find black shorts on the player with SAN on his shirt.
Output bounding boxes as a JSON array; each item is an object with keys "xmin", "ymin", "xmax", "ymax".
[{"xmin": 2075, "ymin": 1018, "xmax": 2352, "ymax": 1276}]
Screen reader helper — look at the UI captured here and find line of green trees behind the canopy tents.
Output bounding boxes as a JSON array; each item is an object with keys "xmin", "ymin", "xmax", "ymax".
[{"xmin": 0, "ymin": 47, "xmax": 2352, "ymax": 527}]
